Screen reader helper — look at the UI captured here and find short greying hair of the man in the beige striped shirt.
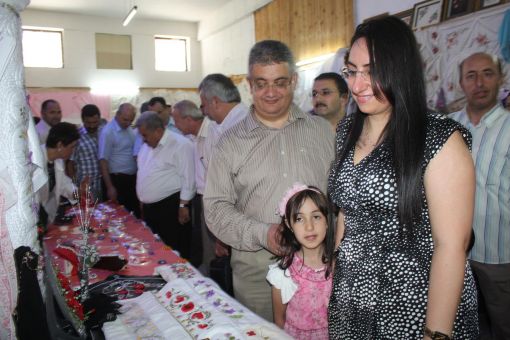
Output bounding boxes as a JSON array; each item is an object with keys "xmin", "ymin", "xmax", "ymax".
[{"xmin": 248, "ymin": 40, "xmax": 296, "ymax": 74}]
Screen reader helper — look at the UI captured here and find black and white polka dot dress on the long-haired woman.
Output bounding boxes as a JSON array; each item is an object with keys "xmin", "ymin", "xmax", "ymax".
[{"xmin": 328, "ymin": 114, "xmax": 478, "ymax": 339}]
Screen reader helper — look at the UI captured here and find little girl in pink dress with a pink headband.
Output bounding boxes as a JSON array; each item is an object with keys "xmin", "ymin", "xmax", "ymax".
[{"xmin": 267, "ymin": 183, "xmax": 335, "ymax": 340}]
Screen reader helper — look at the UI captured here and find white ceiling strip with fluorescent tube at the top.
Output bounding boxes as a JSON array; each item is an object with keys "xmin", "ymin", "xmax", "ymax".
[{"xmin": 28, "ymin": 0, "xmax": 230, "ymax": 22}]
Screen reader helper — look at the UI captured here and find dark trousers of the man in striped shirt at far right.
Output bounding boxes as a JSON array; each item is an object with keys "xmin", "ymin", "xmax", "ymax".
[{"xmin": 470, "ymin": 261, "xmax": 510, "ymax": 340}]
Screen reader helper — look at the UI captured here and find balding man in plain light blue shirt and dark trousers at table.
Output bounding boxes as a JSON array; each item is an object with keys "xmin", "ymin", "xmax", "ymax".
[{"xmin": 99, "ymin": 103, "xmax": 140, "ymax": 217}]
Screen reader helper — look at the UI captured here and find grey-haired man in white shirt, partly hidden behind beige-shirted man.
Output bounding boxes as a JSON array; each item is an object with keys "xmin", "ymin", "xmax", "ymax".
[{"xmin": 197, "ymin": 73, "xmax": 248, "ymax": 275}]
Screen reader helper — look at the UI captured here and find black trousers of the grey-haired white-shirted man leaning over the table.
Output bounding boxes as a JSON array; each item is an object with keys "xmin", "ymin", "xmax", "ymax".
[{"xmin": 143, "ymin": 192, "xmax": 191, "ymax": 259}]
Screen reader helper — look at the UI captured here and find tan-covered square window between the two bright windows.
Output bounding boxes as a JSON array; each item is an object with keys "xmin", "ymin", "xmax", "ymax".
[{"xmin": 96, "ymin": 33, "xmax": 133, "ymax": 70}]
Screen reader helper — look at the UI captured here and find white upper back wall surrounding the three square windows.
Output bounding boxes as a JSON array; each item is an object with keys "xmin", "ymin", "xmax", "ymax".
[{"xmin": 22, "ymin": 10, "xmax": 202, "ymax": 88}]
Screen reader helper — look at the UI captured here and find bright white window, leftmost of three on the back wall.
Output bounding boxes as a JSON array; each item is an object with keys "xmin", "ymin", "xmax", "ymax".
[{"xmin": 22, "ymin": 27, "xmax": 64, "ymax": 68}]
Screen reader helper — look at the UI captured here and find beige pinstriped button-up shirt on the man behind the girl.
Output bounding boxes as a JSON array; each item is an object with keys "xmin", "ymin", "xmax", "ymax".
[{"xmin": 204, "ymin": 105, "xmax": 335, "ymax": 251}]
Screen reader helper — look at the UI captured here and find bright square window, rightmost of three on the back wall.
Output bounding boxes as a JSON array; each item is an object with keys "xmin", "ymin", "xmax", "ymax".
[{"xmin": 154, "ymin": 35, "xmax": 190, "ymax": 72}]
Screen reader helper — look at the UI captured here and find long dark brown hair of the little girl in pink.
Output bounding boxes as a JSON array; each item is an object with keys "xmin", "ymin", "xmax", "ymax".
[{"xmin": 275, "ymin": 186, "xmax": 335, "ymax": 278}]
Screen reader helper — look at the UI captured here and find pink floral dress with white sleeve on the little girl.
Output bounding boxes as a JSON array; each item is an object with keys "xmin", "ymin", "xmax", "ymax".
[{"xmin": 267, "ymin": 255, "xmax": 333, "ymax": 340}]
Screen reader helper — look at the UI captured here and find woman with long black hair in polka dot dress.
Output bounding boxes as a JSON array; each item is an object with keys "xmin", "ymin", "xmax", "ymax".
[{"xmin": 328, "ymin": 16, "xmax": 478, "ymax": 339}]
